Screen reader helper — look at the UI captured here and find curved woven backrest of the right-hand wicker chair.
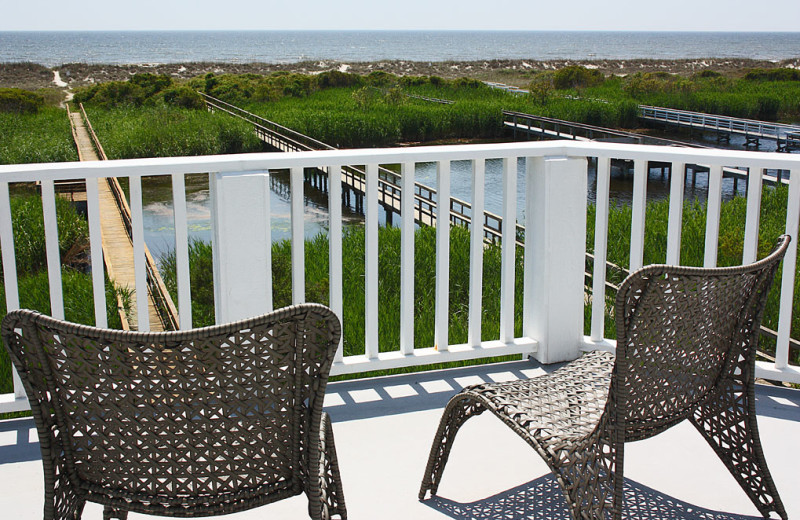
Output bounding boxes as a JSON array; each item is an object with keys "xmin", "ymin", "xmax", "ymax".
[{"xmin": 611, "ymin": 235, "xmax": 790, "ymax": 440}]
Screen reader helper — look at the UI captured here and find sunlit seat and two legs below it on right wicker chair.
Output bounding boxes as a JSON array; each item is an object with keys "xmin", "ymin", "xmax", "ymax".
[{"xmin": 419, "ymin": 352, "xmax": 616, "ymax": 518}]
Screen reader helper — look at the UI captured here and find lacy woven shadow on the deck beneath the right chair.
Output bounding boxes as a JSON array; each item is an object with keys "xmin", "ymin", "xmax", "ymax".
[{"xmin": 424, "ymin": 475, "xmax": 761, "ymax": 520}]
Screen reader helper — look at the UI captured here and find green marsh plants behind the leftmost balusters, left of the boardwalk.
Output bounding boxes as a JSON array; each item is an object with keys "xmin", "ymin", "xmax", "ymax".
[{"xmin": 0, "ymin": 189, "xmax": 130, "ymax": 393}]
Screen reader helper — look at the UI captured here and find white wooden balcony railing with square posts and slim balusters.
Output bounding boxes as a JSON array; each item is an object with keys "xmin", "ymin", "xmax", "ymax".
[{"xmin": 0, "ymin": 142, "xmax": 800, "ymax": 412}]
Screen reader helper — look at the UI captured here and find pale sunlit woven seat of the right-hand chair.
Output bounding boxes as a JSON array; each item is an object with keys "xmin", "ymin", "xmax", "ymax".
[{"xmin": 461, "ymin": 351, "xmax": 614, "ymax": 444}]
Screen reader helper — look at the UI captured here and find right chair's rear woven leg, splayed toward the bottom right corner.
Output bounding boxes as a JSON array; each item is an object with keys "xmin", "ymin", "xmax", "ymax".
[{"xmin": 690, "ymin": 383, "xmax": 787, "ymax": 520}]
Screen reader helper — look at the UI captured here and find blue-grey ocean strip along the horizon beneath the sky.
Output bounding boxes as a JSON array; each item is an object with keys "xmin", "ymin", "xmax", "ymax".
[{"xmin": 0, "ymin": 31, "xmax": 800, "ymax": 67}]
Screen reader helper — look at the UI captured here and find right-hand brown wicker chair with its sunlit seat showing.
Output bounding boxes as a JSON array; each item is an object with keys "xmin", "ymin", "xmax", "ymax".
[{"xmin": 419, "ymin": 236, "xmax": 789, "ymax": 519}]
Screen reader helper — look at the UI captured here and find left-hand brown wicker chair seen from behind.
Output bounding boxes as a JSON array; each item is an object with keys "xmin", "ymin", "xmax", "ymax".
[{"xmin": 2, "ymin": 304, "xmax": 347, "ymax": 520}]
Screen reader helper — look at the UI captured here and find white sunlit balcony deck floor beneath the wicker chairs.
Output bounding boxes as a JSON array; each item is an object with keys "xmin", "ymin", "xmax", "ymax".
[{"xmin": 0, "ymin": 361, "xmax": 800, "ymax": 520}]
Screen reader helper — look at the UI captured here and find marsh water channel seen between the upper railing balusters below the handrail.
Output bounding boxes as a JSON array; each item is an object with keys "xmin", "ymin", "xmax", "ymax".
[{"xmin": 142, "ymin": 154, "xmax": 744, "ymax": 258}]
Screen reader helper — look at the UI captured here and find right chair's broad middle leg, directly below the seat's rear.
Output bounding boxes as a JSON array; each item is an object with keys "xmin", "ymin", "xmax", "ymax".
[{"xmin": 552, "ymin": 435, "xmax": 624, "ymax": 520}]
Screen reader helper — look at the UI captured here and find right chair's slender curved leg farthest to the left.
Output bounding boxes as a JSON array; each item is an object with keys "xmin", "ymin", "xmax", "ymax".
[{"xmin": 419, "ymin": 394, "xmax": 486, "ymax": 500}]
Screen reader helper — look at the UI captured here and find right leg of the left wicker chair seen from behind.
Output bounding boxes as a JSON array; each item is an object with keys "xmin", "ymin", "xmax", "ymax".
[{"xmin": 308, "ymin": 412, "xmax": 347, "ymax": 520}]
